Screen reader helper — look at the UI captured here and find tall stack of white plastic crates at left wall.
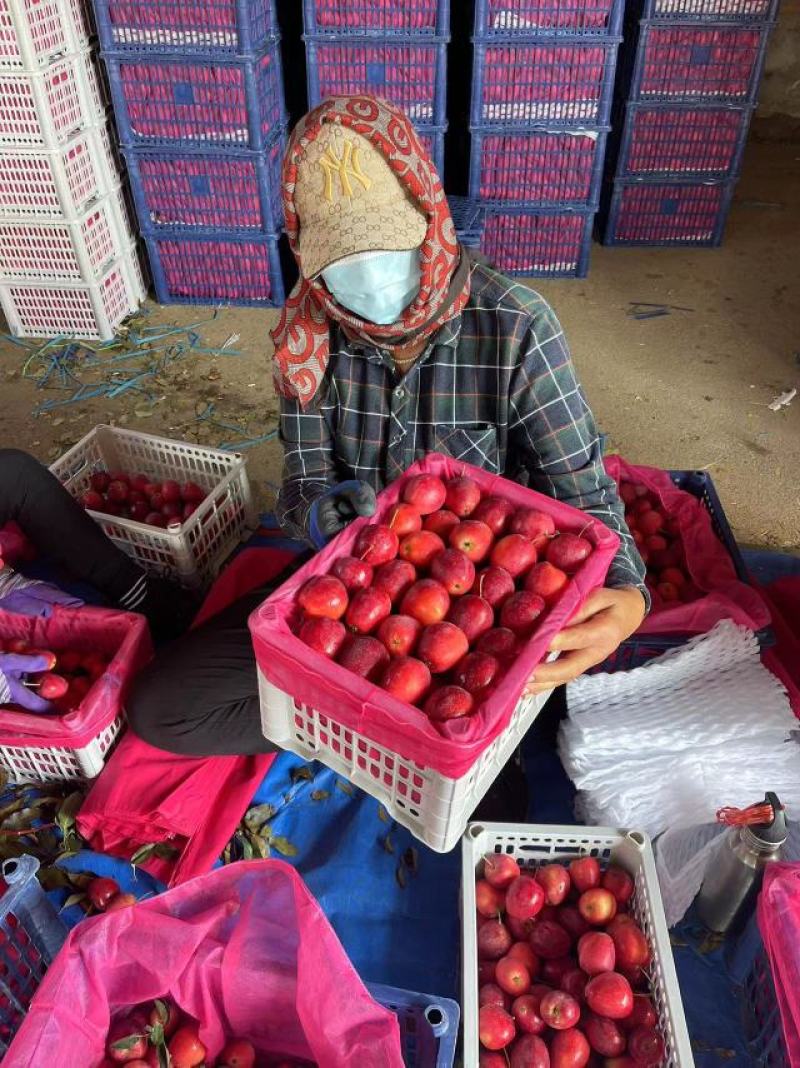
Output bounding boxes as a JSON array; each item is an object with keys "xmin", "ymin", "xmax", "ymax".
[{"xmin": 0, "ymin": 0, "xmax": 144, "ymax": 340}]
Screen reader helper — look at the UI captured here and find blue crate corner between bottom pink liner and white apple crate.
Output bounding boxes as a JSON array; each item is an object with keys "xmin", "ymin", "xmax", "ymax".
[{"xmin": 366, "ymin": 983, "xmax": 460, "ymax": 1068}]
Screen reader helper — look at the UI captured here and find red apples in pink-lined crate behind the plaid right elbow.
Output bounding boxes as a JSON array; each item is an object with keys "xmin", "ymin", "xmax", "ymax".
[{"xmin": 619, "ymin": 482, "xmax": 703, "ymax": 609}]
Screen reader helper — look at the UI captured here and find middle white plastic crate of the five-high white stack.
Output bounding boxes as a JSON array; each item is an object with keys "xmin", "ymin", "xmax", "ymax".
[{"xmin": 0, "ymin": 123, "xmax": 121, "ymax": 220}]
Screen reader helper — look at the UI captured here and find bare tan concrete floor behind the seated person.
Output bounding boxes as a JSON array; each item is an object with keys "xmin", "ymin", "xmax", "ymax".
[{"xmin": 0, "ymin": 144, "xmax": 800, "ymax": 552}]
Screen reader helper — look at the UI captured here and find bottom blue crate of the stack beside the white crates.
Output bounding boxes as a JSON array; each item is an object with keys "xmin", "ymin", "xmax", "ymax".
[{"xmin": 144, "ymin": 230, "xmax": 285, "ymax": 308}]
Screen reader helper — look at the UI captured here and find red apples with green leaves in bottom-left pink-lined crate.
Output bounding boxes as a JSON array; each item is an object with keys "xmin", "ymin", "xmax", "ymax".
[{"xmin": 99, "ymin": 998, "xmax": 308, "ymax": 1068}]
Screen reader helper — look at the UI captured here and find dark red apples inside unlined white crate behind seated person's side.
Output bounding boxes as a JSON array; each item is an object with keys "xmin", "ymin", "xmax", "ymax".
[{"xmin": 80, "ymin": 471, "xmax": 208, "ymax": 527}]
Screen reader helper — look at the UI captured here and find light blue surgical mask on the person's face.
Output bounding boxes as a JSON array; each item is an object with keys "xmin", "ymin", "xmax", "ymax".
[{"xmin": 323, "ymin": 249, "xmax": 420, "ymax": 326}]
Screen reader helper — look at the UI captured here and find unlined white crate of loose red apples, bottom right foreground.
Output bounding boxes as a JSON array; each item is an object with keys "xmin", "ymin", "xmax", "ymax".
[{"xmin": 462, "ymin": 823, "xmax": 692, "ymax": 1068}]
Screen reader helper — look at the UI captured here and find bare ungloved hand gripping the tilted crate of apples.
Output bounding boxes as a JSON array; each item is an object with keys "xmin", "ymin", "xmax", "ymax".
[{"xmin": 526, "ymin": 586, "xmax": 645, "ymax": 693}]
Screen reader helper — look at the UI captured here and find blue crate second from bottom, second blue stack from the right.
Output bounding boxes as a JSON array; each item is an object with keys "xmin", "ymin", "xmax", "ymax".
[{"xmin": 469, "ymin": 126, "xmax": 608, "ymax": 207}]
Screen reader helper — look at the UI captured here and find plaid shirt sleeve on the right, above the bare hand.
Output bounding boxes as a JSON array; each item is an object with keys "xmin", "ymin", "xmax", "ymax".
[{"xmin": 508, "ymin": 301, "xmax": 650, "ymax": 610}]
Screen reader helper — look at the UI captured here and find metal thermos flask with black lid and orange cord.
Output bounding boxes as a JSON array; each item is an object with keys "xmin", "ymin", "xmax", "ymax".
[{"xmin": 694, "ymin": 794, "xmax": 787, "ymax": 933}]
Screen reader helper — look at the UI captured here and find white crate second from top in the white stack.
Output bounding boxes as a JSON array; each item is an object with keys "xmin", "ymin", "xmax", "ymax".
[{"xmin": 0, "ymin": 48, "xmax": 106, "ymax": 148}]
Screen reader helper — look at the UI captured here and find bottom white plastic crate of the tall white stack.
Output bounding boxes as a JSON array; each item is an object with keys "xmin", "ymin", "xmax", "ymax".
[{"xmin": 0, "ymin": 246, "xmax": 146, "ymax": 341}]
